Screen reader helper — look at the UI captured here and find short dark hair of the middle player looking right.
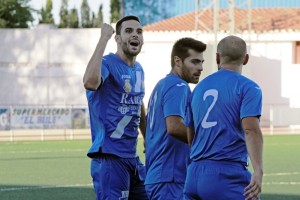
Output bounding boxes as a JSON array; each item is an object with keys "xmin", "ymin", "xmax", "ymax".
[{"xmin": 171, "ymin": 37, "xmax": 206, "ymax": 67}]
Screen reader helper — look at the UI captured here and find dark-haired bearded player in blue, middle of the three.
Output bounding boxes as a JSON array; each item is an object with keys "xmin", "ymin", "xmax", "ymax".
[{"xmin": 145, "ymin": 38, "xmax": 206, "ymax": 200}]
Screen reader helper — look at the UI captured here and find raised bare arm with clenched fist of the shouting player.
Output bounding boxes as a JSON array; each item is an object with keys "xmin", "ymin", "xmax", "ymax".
[{"xmin": 83, "ymin": 23, "xmax": 115, "ymax": 90}]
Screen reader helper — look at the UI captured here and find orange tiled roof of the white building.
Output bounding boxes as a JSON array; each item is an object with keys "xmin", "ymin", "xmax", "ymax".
[{"xmin": 144, "ymin": 8, "xmax": 300, "ymax": 32}]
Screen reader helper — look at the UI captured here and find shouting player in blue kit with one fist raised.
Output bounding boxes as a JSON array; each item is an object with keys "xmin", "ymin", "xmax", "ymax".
[{"xmin": 83, "ymin": 16, "xmax": 147, "ymax": 200}]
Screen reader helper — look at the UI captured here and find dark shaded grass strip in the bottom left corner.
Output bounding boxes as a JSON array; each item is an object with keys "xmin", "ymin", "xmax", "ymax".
[{"xmin": 0, "ymin": 185, "xmax": 96, "ymax": 200}]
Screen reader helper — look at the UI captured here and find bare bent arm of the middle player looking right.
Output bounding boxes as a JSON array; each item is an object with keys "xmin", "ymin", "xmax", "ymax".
[{"xmin": 166, "ymin": 115, "xmax": 188, "ymax": 143}]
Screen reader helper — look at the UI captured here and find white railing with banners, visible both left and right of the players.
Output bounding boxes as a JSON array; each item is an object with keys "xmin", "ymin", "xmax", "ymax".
[{"xmin": 0, "ymin": 105, "xmax": 300, "ymax": 141}]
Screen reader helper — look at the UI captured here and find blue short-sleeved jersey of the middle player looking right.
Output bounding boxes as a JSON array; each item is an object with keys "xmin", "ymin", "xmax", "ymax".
[{"xmin": 145, "ymin": 74, "xmax": 191, "ymax": 184}]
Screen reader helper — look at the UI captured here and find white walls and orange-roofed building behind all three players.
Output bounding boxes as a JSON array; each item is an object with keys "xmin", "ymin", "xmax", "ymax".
[{"xmin": 0, "ymin": 8, "xmax": 300, "ymax": 129}]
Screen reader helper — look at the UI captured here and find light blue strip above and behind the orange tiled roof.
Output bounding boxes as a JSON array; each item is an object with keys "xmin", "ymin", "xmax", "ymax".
[{"xmin": 122, "ymin": 0, "xmax": 300, "ymax": 25}]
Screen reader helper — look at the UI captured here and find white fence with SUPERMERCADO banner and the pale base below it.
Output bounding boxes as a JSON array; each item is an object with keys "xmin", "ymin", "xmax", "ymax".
[{"xmin": 0, "ymin": 105, "xmax": 90, "ymax": 141}]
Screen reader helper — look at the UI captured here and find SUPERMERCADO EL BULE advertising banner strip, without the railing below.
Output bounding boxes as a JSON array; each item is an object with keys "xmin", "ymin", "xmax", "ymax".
[{"xmin": 0, "ymin": 105, "xmax": 89, "ymax": 130}]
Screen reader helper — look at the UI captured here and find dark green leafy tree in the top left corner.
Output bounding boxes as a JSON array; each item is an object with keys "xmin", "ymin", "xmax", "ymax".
[{"xmin": 0, "ymin": 0, "xmax": 34, "ymax": 28}]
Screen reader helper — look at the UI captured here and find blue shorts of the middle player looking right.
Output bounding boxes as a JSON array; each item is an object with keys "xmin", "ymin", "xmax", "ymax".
[{"xmin": 146, "ymin": 182, "xmax": 184, "ymax": 200}]
